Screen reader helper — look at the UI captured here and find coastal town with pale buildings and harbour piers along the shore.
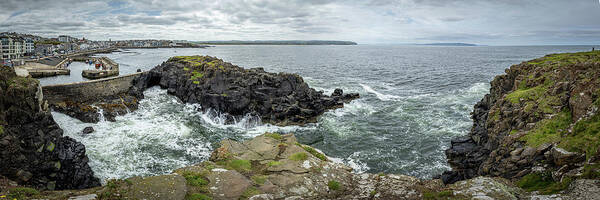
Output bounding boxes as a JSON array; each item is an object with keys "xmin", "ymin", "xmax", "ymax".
[{"xmin": 0, "ymin": 32, "xmax": 207, "ymax": 79}]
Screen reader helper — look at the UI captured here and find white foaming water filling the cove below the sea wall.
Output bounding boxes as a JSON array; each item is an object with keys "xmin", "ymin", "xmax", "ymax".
[{"xmin": 52, "ymin": 88, "xmax": 211, "ymax": 181}]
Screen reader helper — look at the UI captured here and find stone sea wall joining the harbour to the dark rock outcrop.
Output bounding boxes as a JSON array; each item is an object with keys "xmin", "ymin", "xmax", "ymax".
[{"xmin": 42, "ymin": 72, "xmax": 145, "ymax": 104}]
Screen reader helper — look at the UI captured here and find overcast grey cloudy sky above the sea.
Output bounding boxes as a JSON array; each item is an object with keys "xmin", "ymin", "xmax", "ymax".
[{"xmin": 0, "ymin": 0, "xmax": 600, "ymax": 45}]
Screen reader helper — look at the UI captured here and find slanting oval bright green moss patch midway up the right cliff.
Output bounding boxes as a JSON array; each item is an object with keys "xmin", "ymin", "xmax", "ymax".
[{"xmin": 521, "ymin": 109, "xmax": 571, "ymax": 147}]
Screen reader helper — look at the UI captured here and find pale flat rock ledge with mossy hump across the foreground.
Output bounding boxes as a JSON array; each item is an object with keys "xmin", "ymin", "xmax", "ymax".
[{"xmin": 0, "ymin": 133, "xmax": 600, "ymax": 200}]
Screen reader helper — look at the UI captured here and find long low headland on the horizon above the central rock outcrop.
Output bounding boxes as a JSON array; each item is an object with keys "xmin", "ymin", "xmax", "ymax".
[{"xmin": 193, "ymin": 40, "xmax": 356, "ymax": 45}]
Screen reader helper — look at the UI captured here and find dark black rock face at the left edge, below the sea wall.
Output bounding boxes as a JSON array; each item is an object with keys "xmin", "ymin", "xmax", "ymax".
[{"xmin": 0, "ymin": 67, "xmax": 100, "ymax": 190}]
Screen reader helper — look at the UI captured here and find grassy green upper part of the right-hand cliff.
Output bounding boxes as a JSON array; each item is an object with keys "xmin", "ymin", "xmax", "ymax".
[{"xmin": 505, "ymin": 51, "xmax": 600, "ymax": 158}]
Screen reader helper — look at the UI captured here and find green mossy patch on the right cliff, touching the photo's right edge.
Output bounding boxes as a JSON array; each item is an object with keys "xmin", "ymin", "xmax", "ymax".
[{"xmin": 558, "ymin": 114, "xmax": 600, "ymax": 158}]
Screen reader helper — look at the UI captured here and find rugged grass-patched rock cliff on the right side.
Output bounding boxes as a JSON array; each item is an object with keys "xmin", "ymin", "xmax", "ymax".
[{"xmin": 442, "ymin": 51, "xmax": 600, "ymax": 183}]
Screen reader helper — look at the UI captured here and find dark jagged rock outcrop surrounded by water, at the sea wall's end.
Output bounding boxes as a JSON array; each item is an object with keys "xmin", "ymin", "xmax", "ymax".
[{"xmin": 131, "ymin": 56, "xmax": 359, "ymax": 125}]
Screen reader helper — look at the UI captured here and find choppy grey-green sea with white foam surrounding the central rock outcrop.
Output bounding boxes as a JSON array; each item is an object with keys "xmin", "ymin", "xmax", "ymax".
[{"xmin": 47, "ymin": 45, "xmax": 591, "ymax": 179}]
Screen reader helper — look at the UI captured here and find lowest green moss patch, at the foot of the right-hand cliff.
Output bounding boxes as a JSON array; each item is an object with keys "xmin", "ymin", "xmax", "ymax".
[{"xmin": 517, "ymin": 172, "xmax": 573, "ymax": 195}]
